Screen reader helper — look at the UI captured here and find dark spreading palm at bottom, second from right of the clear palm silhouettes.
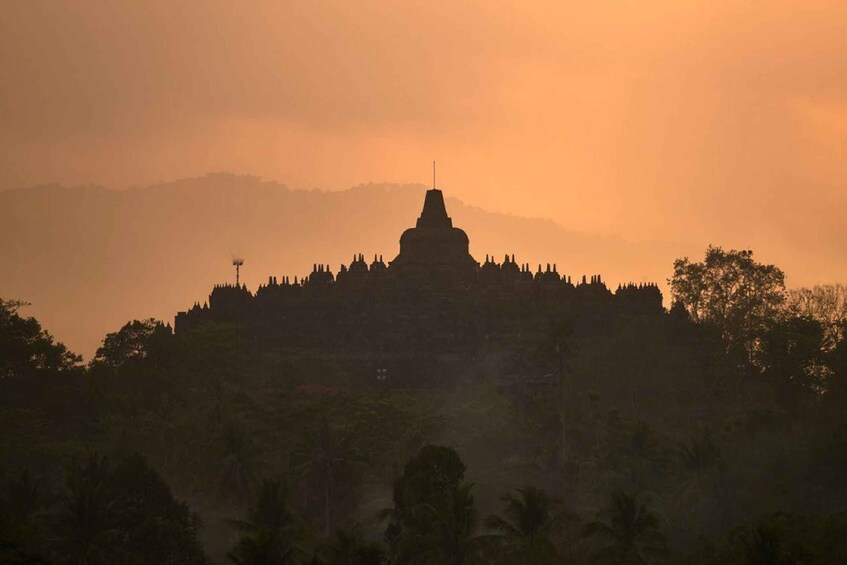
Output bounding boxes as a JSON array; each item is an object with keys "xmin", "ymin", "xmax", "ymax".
[{"xmin": 485, "ymin": 486, "xmax": 566, "ymax": 563}]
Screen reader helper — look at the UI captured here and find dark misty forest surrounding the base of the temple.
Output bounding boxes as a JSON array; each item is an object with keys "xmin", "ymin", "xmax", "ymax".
[{"xmin": 0, "ymin": 247, "xmax": 847, "ymax": 565}]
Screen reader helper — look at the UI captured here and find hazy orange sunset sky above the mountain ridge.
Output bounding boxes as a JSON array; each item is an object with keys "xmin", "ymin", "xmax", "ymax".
[{"xmin": 0, "ymin": 0, "xmax": 847, "ymax": 283}]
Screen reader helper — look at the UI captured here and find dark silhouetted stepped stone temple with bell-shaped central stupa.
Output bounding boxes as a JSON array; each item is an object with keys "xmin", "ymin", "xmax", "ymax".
[{"xmin": 174, "ymin": 189, "xmax": 664, "ymax": 384}]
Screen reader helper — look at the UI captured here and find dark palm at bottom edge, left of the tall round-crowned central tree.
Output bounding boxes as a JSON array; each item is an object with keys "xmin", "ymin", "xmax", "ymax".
[{"xmin": 228, "ymin": 479, "xmax": 300, "ymax": 565}]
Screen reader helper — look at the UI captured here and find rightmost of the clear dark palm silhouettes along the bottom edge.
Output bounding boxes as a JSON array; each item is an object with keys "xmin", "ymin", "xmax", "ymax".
[{"xmin": 584, "ymin": 490, "xmax": 665, "ymax": 565}]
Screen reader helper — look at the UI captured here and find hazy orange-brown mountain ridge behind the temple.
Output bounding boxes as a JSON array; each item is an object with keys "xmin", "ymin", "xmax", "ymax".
[{"xmin": 0, "ymin": 173, "xmax": 682, "ymax": 357}]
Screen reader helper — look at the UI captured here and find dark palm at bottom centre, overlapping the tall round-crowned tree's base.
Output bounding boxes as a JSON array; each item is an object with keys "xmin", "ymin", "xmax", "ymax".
[{"xmin": 395, "ymin": 483, "xmax": 485, "ymax": 565}]
